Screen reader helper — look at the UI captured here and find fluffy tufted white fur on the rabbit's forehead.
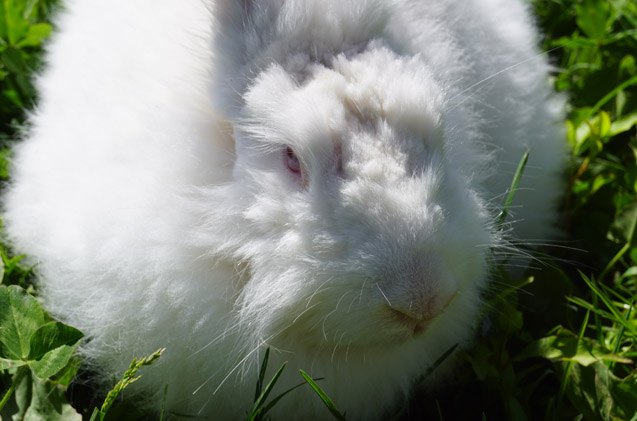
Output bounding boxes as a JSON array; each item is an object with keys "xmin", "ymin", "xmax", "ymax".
[{"xmin": 238, "ymin": 49, "xmax": 445, "ymax": 182}]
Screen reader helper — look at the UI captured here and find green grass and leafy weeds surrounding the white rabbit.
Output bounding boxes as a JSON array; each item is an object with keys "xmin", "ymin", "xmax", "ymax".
[{"xmin": 0, "ymin": 0, "xmax": 637, "ymax": 420}]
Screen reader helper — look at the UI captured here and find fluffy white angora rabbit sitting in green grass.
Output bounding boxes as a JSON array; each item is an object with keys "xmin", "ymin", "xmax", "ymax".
[{"xmin": 5, "ymin": 0, "xmax": 565, "ymax": 419}]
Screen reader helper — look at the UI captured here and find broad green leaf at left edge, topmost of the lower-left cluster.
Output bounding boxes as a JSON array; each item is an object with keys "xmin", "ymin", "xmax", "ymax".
[{"xmin": 0, "ymin": 285, "xmax": 48, "ymax": 360}]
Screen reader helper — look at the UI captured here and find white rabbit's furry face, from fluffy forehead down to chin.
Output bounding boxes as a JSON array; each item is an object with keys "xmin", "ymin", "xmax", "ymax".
[{"xmin": 230, "ymin": 48, "xmax": 491, "ymax": 347}]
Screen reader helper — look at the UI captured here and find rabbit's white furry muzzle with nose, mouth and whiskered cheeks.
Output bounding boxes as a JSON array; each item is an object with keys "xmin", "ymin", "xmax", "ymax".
[{"xmin": 236, "ymin": 176, "xmax": 490, "ymax": 352}]
